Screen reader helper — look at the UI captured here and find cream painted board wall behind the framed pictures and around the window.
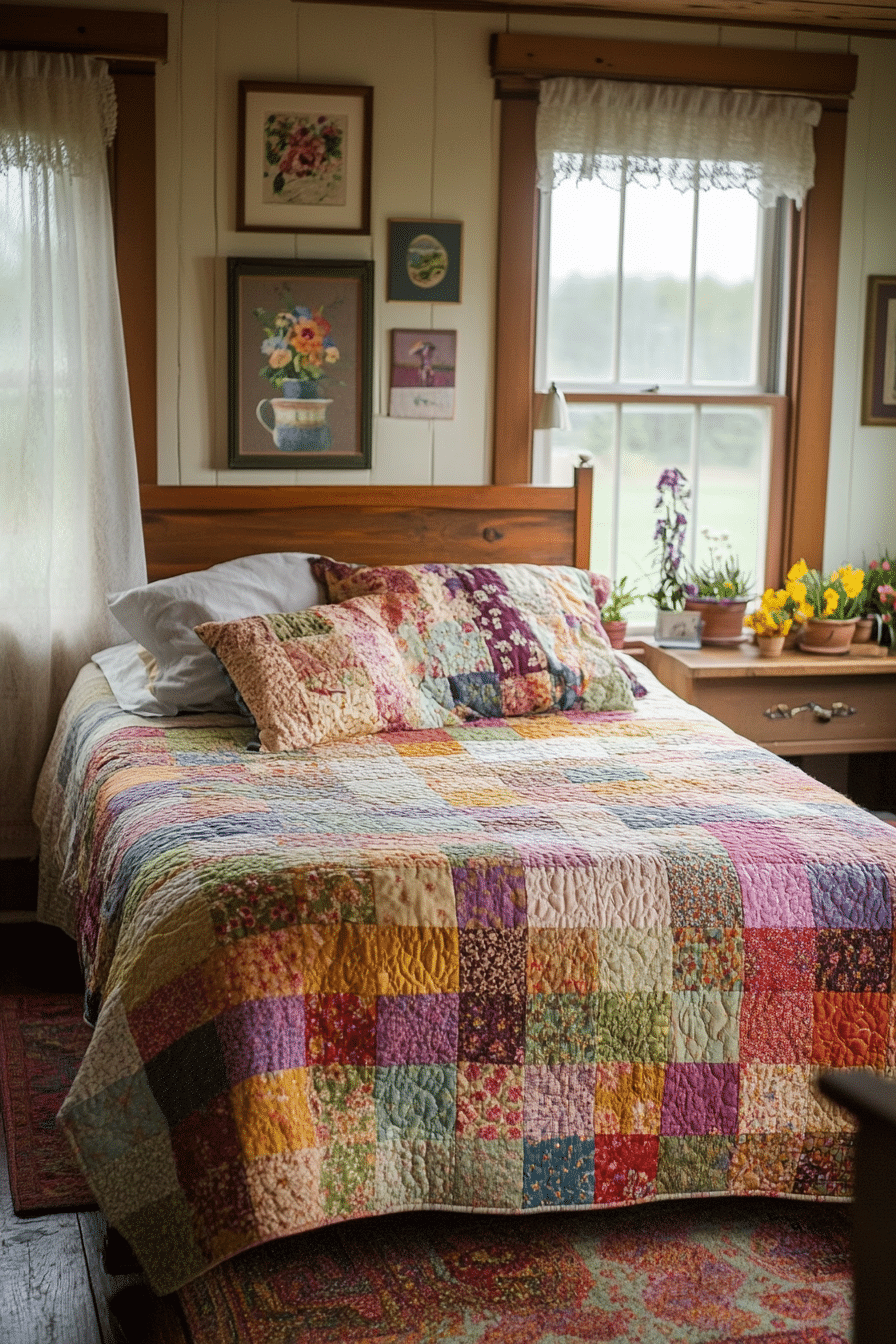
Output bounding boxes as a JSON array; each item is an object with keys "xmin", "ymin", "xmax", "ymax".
[{"xmin": 12, "ymin": 0, "xmax": 896, "ymax": 564}]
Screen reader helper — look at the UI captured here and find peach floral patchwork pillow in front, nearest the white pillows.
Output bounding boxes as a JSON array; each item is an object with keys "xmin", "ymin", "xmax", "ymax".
[{"xmin": 196, "ymin": 595, "xmax": 448, "ymax": 751}]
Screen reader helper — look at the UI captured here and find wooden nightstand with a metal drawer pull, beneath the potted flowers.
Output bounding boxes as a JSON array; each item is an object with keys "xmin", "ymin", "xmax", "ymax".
[{"xmin": 643, "ymin": 641, "xmax": 896, "ymax": 757}]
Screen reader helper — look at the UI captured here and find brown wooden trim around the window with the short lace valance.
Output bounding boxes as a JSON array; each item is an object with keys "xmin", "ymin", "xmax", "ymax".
[{"xmin": 492, "ymin": 34, "xmax": 857, "ymax": 578}]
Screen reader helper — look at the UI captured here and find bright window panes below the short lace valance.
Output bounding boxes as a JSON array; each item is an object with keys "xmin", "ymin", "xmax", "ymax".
[{"xmin": 532, "ymin": 172, "xmax": 790, "ymax": 621}]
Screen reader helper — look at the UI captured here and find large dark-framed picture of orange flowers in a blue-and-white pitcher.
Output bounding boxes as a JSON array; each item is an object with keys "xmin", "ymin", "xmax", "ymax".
[{"xmin": 227, "ymin": 257, "xmax": 373, "ymax": 470}]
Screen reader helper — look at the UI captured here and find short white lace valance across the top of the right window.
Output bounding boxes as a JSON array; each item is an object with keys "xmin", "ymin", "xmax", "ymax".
[{"xmin": 536, "ymin": 78, "xmax": 821, "ymax": 206}]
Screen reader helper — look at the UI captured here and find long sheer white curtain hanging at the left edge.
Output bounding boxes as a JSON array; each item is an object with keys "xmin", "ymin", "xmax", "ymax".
[{"xmin": 0, "ymin": 52, "xmax": 146, "ymax": 857}]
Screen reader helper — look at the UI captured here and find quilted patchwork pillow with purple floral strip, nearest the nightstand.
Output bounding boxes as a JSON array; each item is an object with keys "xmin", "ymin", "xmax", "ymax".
[{"xmin": 312, "ymin": 556, "xmax": 634, "ymax": 719}]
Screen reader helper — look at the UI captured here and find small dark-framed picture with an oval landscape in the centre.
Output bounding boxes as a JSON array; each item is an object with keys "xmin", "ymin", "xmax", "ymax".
[{"xmin": 386, "ymin": 219, "xmax": 463, "ymax": 304}]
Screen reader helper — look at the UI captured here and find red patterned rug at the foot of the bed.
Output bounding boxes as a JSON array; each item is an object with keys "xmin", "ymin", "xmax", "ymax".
[{"xmin": 179, "ymin": 1199, "xmax": 852, "ymax": 1344}]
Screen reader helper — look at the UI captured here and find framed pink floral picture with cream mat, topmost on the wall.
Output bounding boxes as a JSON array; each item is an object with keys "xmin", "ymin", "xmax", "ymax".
[{"xmin": 236, "ymin": 79, "xmax": 373, "ymax": 234}]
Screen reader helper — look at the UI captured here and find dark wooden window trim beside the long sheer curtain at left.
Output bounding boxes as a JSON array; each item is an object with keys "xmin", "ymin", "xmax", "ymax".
[{"xmin": 0, "ymin": 4, "xmax": 168, "ymax": 482}]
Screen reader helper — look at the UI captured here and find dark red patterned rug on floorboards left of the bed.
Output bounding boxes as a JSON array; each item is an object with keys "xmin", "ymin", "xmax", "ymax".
[{"xmin": 0, "ymin": 995, "xmax": 97, "ymax": 1215}]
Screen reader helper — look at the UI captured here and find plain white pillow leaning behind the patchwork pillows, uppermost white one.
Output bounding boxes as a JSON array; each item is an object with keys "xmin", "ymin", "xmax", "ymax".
[{"xmin": 107, "ymin": 551, "xmax": 326, "ymax": 714}]
